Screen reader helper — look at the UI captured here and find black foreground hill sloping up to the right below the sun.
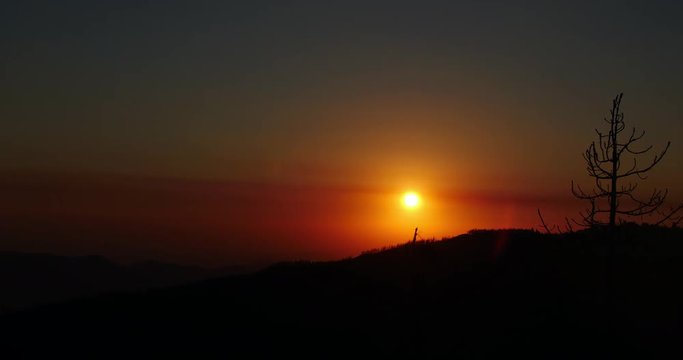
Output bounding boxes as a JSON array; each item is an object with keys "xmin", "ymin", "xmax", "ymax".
[{"xmin": 0, "ymin": 225, "xmax": 683, "ymax": 358}]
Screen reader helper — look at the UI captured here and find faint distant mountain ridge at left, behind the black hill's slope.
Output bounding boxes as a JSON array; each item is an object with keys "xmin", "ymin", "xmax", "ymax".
[{"xmin": 0, "ymin": 252, "xmax": 254, "ymax": 313}]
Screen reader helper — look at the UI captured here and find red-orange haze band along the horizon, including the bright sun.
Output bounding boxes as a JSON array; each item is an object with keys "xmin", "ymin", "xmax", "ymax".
[{"xmin": 0, "ymin": 170, "xmax": 576, "ymax": 266}]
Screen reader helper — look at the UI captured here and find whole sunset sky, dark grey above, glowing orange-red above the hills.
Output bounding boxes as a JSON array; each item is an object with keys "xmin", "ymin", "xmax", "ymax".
[{"xmin": 0, "ymin": 0, "xmax": 683, "ymax": 265}]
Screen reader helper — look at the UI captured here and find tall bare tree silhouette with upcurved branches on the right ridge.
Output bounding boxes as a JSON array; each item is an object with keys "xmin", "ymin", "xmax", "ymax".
[{"xmin": 572, "ymin": 93, "xmax": 683, "ymax": 229}]
